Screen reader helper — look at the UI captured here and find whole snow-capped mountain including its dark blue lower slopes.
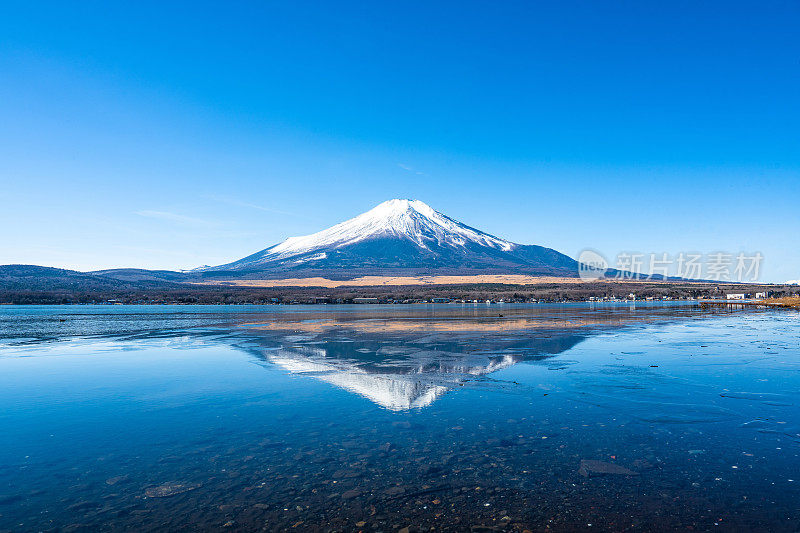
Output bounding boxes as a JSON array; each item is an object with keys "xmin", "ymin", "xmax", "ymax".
[{"xmin": 193, "ymin": 199, "xmax": 578, "ymax": 279}]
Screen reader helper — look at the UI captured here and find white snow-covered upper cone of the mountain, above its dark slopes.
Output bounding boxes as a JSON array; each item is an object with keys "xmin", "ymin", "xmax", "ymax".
[{"xmin": 262, "ymin": 199, "xmax": 516, "ymax": 261}]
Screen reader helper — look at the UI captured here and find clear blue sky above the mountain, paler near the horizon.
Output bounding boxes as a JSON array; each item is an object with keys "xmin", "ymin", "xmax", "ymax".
[{"xmin": 0, "ymin": 1, "xmax": 800, "ymax": 281}]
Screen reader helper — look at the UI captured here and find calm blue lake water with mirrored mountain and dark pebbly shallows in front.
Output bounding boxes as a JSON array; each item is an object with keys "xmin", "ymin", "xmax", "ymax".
[{"xmin": 0, "ymin": 304, "xmax": 800, "ymax": 532}]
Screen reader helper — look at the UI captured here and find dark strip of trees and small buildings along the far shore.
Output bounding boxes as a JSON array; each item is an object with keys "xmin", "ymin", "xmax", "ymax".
[{"xmin": 0, "ymin": 281, "xmax": 800, "ymax": 306}]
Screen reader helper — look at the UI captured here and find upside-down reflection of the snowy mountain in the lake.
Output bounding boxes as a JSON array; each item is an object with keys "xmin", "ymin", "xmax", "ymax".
[{"xmin": 241, "ymin": 332, "xmax": 585, "ymax": 411}]
